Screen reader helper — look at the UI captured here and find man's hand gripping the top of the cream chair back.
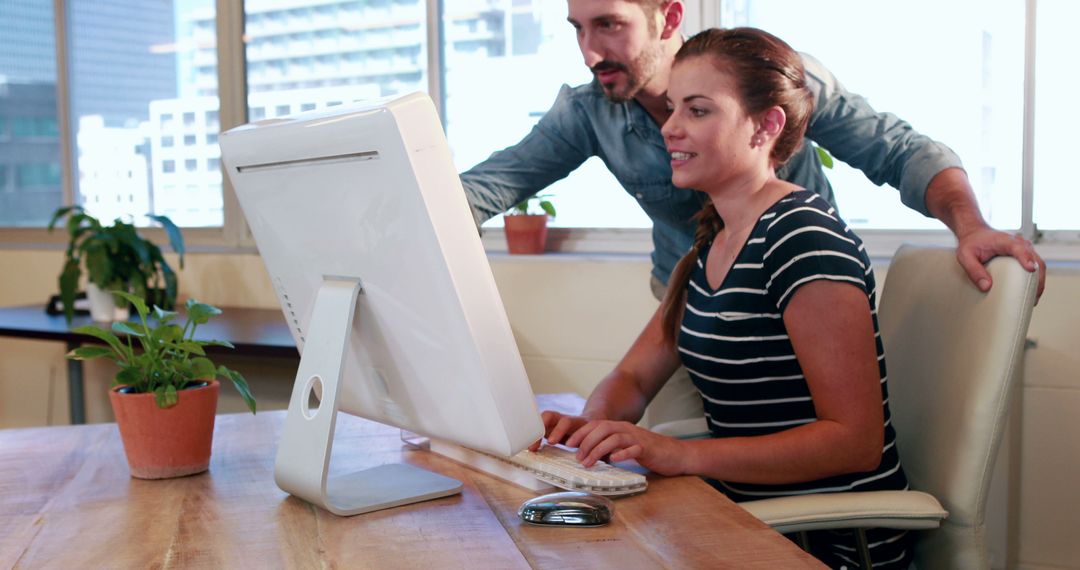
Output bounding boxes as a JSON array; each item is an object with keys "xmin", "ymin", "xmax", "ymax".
[{"xmin": 956, "ymin": 227, "xmax": 1047, "ymax": 299}]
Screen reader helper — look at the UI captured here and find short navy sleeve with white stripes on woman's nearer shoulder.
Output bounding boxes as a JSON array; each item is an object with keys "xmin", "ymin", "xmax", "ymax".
[{"xmin": 762, "ymin": 198, "xmax": 870, "ymax": 314}]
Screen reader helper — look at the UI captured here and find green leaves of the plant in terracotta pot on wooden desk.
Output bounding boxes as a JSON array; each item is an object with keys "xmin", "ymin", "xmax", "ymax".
[{"xmin": 67, "ymin": 291, "xmax": 255, "ymax": 413}]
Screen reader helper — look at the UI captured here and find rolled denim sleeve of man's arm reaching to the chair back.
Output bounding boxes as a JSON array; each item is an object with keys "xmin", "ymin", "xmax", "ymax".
[{"xmin": 801, "ymin": 54, "xmax": 962, "ymax": 216}]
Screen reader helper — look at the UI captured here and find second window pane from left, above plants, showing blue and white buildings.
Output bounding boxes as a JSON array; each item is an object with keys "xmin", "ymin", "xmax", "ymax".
[{"xmin": 67, "ymin": 0, "xmax": 222, "ymax": 227}]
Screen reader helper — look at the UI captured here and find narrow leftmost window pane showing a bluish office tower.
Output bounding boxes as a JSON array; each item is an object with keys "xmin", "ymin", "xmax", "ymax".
[{"xmin": 0, "ymin": 0, "xmax": 64, "ymax": 228}]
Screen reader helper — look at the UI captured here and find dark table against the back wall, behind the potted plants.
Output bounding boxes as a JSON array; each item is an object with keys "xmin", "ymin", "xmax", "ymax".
[{"xmin": 0, "ymin": 304, "xmax": 300, "ymax": 423}]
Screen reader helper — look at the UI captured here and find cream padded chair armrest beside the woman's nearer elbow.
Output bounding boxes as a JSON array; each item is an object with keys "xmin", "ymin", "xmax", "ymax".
[{"xmin": 739, "ymin": 491, "xmax": 948, "ymax": 534}]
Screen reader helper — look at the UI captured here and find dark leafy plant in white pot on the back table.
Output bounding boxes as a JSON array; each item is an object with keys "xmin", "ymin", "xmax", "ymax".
[{"xmin": 49, "ymin": 206, "xmax": 184, "ymax": 323}]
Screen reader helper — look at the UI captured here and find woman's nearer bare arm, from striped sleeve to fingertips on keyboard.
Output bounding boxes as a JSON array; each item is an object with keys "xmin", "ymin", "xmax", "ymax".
[{"xmin": 566, "ymin": 281, "xmax": 885, "ymax": 485}]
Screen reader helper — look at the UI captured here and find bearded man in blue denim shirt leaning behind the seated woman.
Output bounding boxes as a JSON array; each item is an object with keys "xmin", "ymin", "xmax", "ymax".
[{"xmin": 461, "ymin": 0, "xmax": 1045, "ymax": 423}]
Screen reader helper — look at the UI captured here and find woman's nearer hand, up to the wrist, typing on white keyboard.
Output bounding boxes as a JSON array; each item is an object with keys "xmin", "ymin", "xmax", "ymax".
[{"xmin": 565, "ymin": 420, "xmax": 689, "ymax": 475}]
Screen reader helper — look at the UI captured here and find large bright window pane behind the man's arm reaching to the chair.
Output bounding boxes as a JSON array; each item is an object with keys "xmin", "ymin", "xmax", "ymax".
[{"xmin": 721, "ymin": 0, "xmax": 1023, "ymax": 229}]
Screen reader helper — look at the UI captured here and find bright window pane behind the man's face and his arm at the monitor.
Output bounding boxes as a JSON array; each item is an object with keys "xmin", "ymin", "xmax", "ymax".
[{"xmin": 443, "ymin": 0, "xmax": 651, "ymax": 228}]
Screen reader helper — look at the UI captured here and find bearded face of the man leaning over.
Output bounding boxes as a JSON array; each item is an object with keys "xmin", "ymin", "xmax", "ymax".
[{"xmin": 567, "ymin": 0, "xmax": 669, "ymax": 101}]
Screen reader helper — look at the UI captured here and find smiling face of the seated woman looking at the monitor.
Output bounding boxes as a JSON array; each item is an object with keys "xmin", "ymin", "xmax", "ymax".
[{"xmin": 661, "ymin": 56, "xmax": 768, "ymax": 192}]
